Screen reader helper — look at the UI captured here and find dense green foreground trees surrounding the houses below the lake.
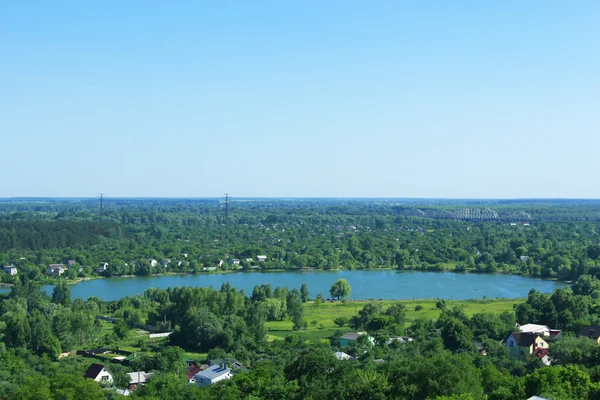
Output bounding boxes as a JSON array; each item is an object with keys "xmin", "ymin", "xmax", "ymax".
[{"xmin": 5, "ymin": 276, "xmax": 600, "ymax": 400}]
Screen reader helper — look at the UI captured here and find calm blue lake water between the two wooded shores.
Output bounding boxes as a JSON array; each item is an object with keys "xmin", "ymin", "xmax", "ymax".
[{"xmin": 3, "ymin": 271, "xmax": 566, "ymax": 300}]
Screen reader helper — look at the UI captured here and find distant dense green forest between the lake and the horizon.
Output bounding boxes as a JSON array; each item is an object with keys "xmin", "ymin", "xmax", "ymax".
[{"xmin": 0, "ymin": 200, "xmax": 600, "ymax": 282}]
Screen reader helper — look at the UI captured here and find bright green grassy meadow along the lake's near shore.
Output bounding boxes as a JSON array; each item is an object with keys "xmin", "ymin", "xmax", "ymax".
[{"xmin": 266, "ymin": 299, "xmax": 524, "ymax": 340}]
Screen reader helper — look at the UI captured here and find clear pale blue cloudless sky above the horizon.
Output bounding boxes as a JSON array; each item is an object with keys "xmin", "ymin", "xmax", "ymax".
[{"xmin": 0, "ymin": 0, "xmax": 600, "ymax": 198}]
